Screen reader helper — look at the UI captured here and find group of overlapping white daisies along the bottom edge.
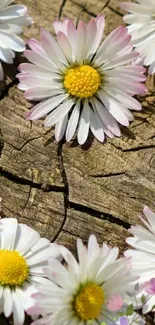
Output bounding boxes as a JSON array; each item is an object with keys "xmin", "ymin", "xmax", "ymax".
[{"xmin": 0, "ymin": 207, "xmax": 155, "ymax": 325}]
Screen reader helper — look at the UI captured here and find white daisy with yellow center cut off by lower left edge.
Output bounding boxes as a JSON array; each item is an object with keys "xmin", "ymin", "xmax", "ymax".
[{"xmin": 0, "ymin": 218, "xmax": 60, "ymax": 325}]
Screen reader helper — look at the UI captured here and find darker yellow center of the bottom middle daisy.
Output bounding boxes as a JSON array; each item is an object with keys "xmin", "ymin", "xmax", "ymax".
[{"xmin": 74, "ymin": 283, "xmax": 104, "ymax": 320}]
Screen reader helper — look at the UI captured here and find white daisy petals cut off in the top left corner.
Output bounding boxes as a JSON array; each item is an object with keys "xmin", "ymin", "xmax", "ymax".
[{"xmin": 0, "ymin": 0, "xmax": 32, "ymax": 80}]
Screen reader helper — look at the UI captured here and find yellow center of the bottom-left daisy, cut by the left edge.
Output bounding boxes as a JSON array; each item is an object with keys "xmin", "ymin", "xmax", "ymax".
[{"xmin": 0, "ymin": 249, "xmax": 29, "ymax": 286}]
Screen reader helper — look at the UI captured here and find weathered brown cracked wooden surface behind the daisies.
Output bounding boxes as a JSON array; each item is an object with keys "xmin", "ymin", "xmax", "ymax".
[{"xmin": 0, "ymin": 0, "xmax": 155, "ymax": 325}]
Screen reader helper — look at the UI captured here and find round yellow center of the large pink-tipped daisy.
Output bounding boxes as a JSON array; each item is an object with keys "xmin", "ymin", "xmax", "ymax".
[{"xmin": 64, "ymin": 65, "xmax": 101, "ymax": 98}]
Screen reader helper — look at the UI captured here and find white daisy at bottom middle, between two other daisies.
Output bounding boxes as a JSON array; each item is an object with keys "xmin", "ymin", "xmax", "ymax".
[{"xmin": 27, "ymin": 235, "xmax": 135, "ymax": 325}]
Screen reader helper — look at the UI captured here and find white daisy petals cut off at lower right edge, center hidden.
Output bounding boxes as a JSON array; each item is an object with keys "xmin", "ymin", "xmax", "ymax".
[{"xmin": 125, "ymin": 206, "xmax": 155, "ymax": 313}]
